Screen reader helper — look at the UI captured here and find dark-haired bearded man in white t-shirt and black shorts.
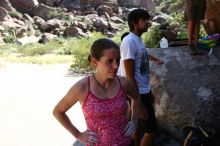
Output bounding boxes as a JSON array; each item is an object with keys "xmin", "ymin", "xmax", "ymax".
[{"xmin": 118, "ymin": 9, "xmax": 163, "ymax": 146}]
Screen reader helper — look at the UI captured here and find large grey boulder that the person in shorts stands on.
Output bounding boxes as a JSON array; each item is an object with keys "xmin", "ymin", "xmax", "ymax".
[{"xmin": 148, "ymin": 47, "xmax": 220, "ymax": 138}]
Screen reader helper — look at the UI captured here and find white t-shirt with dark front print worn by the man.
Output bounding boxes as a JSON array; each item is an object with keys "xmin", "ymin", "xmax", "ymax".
[{"xmin": 118, "ymin": 32, "xmax": 150, "ymax": 94}]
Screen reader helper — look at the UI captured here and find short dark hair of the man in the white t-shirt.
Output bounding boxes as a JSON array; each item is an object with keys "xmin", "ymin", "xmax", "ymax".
[{"xmin": 128, "ymin": 9, "xmax": 150, "ymax": 31}]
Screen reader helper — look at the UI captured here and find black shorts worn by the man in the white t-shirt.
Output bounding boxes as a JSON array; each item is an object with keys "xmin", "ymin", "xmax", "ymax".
[{"xmin": 137, "ymin": 91, "xmax": 158, "ymax": 137}]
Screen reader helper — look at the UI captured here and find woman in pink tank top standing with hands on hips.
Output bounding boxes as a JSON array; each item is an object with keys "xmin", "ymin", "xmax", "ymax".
[{"xmin": 53, "ymin": 39, "xmax": 141, "ymax": 146}]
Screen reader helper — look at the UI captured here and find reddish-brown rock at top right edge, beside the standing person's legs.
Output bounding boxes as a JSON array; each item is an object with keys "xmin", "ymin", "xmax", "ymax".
[{"xmin": 204, "ymin": 0, "xmax": 220, "ymax": 35}]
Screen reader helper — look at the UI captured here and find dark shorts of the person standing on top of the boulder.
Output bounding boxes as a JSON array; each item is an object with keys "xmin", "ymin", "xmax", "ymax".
[{"xmin": 184, "ymin": 0, "xmax": 206, "ymax": 21}]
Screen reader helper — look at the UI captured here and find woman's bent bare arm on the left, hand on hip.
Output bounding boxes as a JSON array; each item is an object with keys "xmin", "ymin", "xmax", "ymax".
[{"xmin": 53, "ymin": 78, "xmax": 98, "ymax": 145}]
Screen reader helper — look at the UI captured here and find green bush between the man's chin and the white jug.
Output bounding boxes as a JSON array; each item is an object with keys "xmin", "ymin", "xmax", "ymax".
[{"xmin": 142, "ymin": 26, "xmax": 161, "ymax": 48}]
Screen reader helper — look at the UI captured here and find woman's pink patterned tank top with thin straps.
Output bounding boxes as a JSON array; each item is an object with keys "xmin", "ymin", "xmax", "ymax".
[{"xmin": 82, "ymin": 76, "xmax": 131, "ymax": 146}]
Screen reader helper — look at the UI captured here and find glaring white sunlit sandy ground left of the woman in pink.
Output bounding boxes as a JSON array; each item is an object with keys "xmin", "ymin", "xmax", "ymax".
[{"xmin": 0, "ymin": 61, "xmax": 85, "ymax": 146}]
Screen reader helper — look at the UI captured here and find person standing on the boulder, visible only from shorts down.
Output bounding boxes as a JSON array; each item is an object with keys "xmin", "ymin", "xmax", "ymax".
[{"xmin": 184, "ymin": 0, "xmax": 206, "ymax": 55}]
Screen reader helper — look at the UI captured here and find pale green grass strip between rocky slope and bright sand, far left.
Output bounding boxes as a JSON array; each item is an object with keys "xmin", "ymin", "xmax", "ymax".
[{"xmin": 0, "ymin": 39, "xmax": 73, "ymax": 64}]
